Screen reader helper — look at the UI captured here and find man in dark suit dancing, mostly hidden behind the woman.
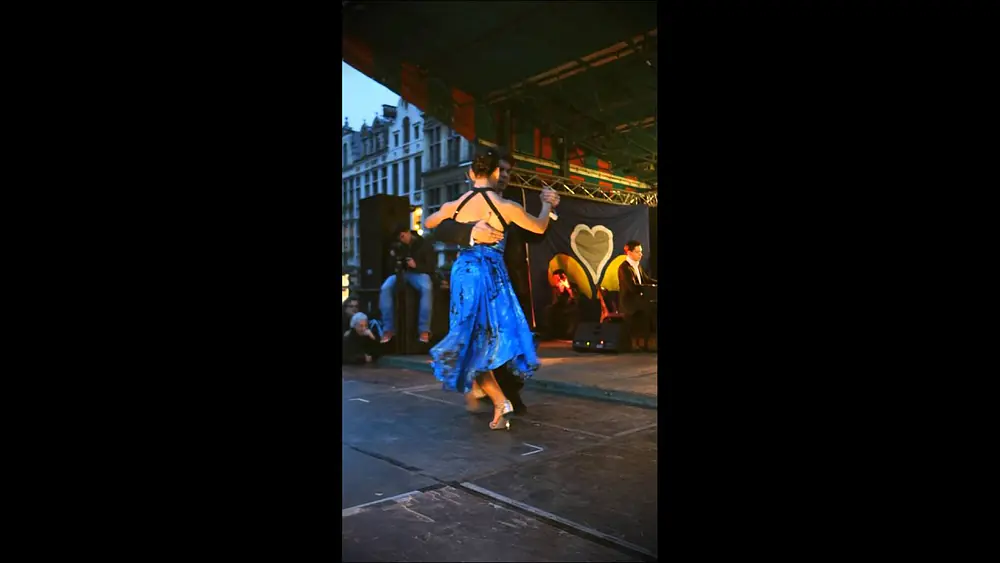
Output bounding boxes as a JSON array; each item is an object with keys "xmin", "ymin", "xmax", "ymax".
[{"xmin": 434, "ymin": 149, "xmax": 558, "ymax": 414}]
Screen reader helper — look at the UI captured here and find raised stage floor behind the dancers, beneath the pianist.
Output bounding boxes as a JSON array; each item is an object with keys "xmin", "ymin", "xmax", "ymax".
[{"xmin": 379, "ymin": 340, "xmax": 658, "ymax": 407}]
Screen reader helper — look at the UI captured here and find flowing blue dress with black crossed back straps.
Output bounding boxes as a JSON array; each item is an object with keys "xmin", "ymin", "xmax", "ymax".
[{"xmin": 431, "ymin": 189, "xmax": 539, "ymax": 393}]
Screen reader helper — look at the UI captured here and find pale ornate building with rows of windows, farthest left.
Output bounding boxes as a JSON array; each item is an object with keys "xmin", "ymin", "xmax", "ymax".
[{"xmin": 341, "ymin": 98, "xmax": 425, "ymax": 268}]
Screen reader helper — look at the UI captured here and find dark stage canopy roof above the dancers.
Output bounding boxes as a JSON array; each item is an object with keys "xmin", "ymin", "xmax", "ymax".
[{"xmin": 343, "ymin": 1, "xmax": 657, "ymax": 186}]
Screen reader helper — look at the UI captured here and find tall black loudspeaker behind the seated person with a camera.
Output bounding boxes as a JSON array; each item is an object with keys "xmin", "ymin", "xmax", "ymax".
[{"xmin": 358, "ymin": 194, "xmax": 410, "ymax": 290}]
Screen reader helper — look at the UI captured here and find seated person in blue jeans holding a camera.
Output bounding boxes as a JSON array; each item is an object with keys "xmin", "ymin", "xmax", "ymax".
[{"xmin": 378, "ymin": 225, "xmax": 435, "ymax": 342}]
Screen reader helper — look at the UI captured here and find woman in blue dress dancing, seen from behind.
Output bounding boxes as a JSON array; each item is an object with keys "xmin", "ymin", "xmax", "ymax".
[{"xmin": 424, "ymin": 147, "xmax": 558, "ymax": 430}]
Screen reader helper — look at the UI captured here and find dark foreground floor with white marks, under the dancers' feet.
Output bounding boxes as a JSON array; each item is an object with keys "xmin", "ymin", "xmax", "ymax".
[{"xmin": 341, "ymin": 366, "xmax": 657, "ymax": 561}]
